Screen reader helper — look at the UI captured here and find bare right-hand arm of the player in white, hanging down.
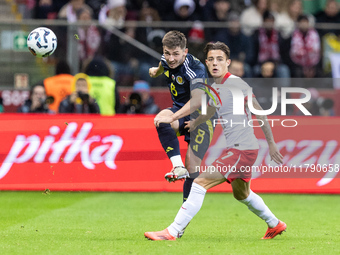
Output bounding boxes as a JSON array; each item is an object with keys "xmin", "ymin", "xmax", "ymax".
[{"xmin": 253, "ymin": 97, "xmax": 283, "ymax": 164}]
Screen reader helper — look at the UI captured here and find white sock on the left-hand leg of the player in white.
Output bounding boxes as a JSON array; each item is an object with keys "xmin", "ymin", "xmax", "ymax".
[{"xmin": 168, "ymin": 183, "xmax": 207, "ymax": 237}]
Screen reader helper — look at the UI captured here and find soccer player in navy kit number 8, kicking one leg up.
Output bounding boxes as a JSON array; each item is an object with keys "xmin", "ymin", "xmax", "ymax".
[{"xmin": 149, "ymin": 31, "xmax": 213, "ymax": 204}]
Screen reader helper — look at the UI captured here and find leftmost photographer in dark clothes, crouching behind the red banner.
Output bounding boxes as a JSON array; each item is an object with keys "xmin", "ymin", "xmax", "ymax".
[{"xmin": 18, "ymin": 82, "xmax": 55, "ymax": 113}]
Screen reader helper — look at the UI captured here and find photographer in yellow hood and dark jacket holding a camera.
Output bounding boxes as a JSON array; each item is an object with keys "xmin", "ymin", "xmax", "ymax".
[{"xmin": 59, "ymin": 73, "xmax": 99, "ymax": 113}]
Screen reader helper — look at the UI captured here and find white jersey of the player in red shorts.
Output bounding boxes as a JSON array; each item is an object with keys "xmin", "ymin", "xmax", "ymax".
[{"xmin": 209, "ymin": 73, "xmax": 259, "ymax": 150}]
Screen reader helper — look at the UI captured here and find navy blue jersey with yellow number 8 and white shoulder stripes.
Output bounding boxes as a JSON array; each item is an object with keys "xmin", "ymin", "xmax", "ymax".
[{"xmin": 161, "ymin": 54, "xmax": 208, "ymax": 107}]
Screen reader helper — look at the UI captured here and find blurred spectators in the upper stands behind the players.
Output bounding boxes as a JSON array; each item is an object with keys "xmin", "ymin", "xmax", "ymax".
[{"xmin": 25, "ymin": 0, "xmax": 340, "ymax": 80}]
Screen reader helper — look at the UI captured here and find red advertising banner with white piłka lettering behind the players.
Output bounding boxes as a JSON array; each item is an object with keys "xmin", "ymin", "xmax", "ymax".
[{"xmin": 0, "ymin": 114, "xmax": 340, "ymax": 193}]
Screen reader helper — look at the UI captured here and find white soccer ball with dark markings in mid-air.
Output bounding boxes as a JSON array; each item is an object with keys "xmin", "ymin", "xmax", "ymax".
[{"xmin": 27, "ymin": 27, "xmax": 57, "ymax": 58}]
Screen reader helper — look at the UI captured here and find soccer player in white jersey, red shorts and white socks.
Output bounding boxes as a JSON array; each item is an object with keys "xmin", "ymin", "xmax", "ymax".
[{"xmin": 144, "ymin": 42, "xmax": 287, "ymax": 240}]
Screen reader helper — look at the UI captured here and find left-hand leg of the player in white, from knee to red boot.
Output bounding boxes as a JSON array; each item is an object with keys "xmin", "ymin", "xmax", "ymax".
[{"xmin": 144, "ymin": 167, "xmax": 225, "ymax": 240}]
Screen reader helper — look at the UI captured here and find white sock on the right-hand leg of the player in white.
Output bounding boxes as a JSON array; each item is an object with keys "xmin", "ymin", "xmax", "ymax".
[{"xmin": 238, "ymin": 190, "xmax": 279, "ymax": 228}]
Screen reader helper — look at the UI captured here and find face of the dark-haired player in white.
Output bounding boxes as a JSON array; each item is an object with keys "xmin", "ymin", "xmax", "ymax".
[{"xmin": 205, "ymin": 50, "xmax": 230, "ymax": 79}]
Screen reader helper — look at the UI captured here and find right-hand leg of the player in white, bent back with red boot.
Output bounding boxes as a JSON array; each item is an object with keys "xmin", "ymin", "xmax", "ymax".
[{"xmin": 231, "ymin": 179, "xmax": 286, "ymax": 239}]
